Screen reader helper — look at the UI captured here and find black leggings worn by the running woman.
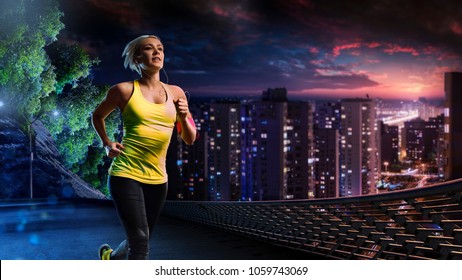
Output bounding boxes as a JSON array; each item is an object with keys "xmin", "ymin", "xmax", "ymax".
[{"xmin": 109, "ymin": 176, "xmax": 167, "ymax": 260}]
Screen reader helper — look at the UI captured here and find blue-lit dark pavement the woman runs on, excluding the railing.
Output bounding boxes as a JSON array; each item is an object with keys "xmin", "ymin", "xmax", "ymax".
[{"xmin": 0, "ymin": 201, "xmax": 323, "ymax": 260}]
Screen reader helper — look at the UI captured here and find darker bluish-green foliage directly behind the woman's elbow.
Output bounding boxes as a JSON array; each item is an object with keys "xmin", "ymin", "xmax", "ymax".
[{"xmin": 44, "ymin": 78, "xmax": 120, "ymax": 194}]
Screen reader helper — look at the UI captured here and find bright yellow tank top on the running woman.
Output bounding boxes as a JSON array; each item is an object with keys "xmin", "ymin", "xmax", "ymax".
[{"xmin": 109, "ymin": 80, "xmax": 176, "ymax": 184}]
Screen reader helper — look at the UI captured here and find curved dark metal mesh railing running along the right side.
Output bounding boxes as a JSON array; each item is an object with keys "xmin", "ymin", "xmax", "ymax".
[{"xmin": 164, "ymin": 179, "xmax": 462, "ymax": 259}]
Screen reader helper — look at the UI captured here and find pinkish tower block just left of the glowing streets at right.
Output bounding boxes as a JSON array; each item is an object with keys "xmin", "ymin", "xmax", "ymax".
[{"xmin": 340, "ymin": 98, "xmax": 381, "ymax": 196}]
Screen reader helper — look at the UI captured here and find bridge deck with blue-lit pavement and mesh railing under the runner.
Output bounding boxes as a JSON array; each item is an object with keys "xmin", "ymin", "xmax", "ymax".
[{"xmin": 0, "ymin": 179, "xmax": 462, "ymax": 260}]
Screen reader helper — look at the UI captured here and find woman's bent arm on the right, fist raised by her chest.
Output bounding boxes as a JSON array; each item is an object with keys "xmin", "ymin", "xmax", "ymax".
[{"xmin": 171, "ymin": 86, "xmax": 197, "ymax": 145}]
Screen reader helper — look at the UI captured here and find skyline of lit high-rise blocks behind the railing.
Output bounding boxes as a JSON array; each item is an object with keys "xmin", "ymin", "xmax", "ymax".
[{"xmin": 169, "ymin": 83, "xmax": 445, "ymax": 201}]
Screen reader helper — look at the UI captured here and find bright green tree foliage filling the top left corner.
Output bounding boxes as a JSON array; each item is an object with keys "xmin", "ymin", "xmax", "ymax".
[{"xmin": 0, "ymin": 0, "xmax": 64, "ymax": 119}]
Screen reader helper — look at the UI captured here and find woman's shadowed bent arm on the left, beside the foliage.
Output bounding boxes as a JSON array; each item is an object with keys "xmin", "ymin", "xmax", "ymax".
[{"xmin": 91, "ymin": 85, "xmax": 124, "ymax": 158}]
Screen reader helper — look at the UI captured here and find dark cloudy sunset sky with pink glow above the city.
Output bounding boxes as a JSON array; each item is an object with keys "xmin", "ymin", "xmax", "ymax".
[{"xmin": 58, "ymin": 0, "xmax": 462, "ymax": 99}]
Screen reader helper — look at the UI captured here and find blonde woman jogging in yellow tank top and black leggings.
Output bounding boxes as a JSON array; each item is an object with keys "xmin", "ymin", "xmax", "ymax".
[{"xmin": 92, "ymin": 35, "xmax": 196, "ymax": 259}]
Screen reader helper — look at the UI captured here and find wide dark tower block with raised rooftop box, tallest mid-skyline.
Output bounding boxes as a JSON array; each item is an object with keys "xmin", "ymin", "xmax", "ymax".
[{"xmin": 249, "ymin": 88, "xmax": 314, "ymax": 200}]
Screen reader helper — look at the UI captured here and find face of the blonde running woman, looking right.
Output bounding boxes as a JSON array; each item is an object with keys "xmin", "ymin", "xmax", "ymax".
[{"xmin": 138, "ymin": 37, "xmax": 164, "ymax": 69}]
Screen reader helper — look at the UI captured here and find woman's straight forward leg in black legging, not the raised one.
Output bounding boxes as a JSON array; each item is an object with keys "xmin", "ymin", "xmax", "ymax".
[{"xmin": 109, "ymin": 176, "xmax": 149, "ymax": 259}]
